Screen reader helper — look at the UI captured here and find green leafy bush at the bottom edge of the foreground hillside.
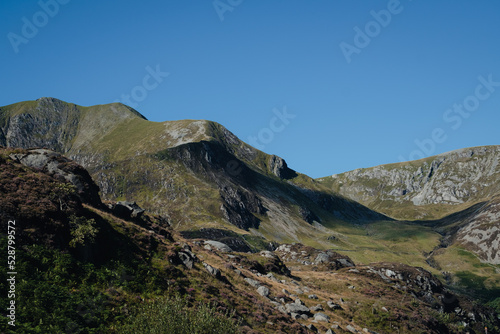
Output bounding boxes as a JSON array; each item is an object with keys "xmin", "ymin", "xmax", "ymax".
[{"xmin": 118, "ymin": 296, "xmax": 239, "ymax": 334}]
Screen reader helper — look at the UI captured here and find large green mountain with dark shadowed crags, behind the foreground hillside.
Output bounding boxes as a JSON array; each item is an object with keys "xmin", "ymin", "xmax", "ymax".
[{"xmin": 0, "ymin": 98, "xmax": 389, "ymax": 246}]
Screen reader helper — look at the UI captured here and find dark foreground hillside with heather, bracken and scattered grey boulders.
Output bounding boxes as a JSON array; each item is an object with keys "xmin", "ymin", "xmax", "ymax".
[{"xmin": 0, "ymin": 148, "xmax": 500, "ymax": 334}]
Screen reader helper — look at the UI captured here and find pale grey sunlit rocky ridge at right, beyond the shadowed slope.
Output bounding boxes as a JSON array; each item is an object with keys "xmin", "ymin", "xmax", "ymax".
[{"xmin": 320, "ymin": 146, "xmax": 500, "ymax": 219}]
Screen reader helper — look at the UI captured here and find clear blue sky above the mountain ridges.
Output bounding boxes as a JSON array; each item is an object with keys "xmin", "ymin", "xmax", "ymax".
[{"xmin": 0, "ymin": 0, "xmax": 500, "ymax": 177}]
